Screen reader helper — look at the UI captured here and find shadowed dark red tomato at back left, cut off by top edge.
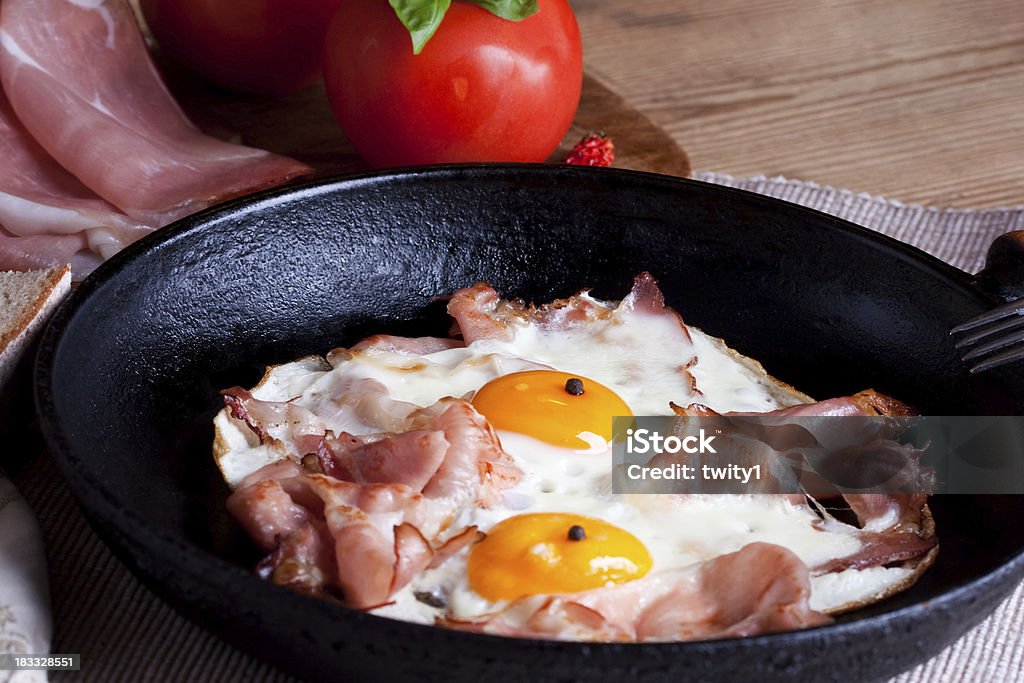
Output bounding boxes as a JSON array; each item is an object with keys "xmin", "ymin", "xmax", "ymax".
[{"xmin": 139, "ymin": 0, "xmax": 344, "ymax": 94}]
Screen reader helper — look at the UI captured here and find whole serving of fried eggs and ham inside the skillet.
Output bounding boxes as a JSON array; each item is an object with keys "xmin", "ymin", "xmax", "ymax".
[{"xmin": 215, "ymin": 273, "xmax": 937, "ymax": 641}]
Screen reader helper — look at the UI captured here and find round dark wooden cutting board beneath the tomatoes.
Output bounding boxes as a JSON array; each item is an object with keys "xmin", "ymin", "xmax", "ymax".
[{"xmin": 158, "ymin": 67, "xmax": 690, "ymax": 177}]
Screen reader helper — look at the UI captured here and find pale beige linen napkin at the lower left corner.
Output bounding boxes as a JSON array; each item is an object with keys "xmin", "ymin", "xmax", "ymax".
[{"xmin": 0, "ymin": 471, "xmax": 52, "ymax": 683}]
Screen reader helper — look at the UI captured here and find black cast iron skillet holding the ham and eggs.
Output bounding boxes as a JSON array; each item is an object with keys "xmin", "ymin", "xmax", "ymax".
[{"xmin": 36, "ymin": 166, "xmax": 1024, "ymax": 682}]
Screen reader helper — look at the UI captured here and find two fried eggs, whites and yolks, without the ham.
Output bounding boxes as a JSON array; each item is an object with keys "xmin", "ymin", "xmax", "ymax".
[{"xmin": 215, "ymin": 286, "xmax": 937, "ymax": 624}]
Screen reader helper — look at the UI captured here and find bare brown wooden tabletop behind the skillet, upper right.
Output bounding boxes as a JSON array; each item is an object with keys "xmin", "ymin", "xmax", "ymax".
[{"xmin": 571, "ymin": 0, "xmax": 1024, "ymax": 207}]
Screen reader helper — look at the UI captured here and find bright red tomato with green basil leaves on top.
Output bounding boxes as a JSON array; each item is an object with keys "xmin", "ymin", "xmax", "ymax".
[{"xmin": 324, "ymin": 0, "xmax": 583, "ymax": 167}]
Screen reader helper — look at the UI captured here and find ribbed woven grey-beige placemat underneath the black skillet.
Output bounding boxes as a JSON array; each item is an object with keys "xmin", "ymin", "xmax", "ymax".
[{"xmin": 15, "ymin": 173, "xmax": 1024, "ymax": 683}]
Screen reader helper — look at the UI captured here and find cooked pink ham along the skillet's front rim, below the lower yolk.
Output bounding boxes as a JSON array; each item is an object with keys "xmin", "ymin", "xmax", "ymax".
[{"xmin": 445, "ymin": 543, "xmax": 830, "ymax": 641}]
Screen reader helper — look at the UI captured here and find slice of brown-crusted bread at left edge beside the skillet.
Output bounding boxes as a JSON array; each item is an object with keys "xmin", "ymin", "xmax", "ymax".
[{"xmin": 0, "ymin": 265, "xmax": 71, "ymax": 389}]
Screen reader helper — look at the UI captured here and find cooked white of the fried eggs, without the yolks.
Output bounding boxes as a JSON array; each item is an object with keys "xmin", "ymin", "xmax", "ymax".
[{"xmin": 215, "ymin": 309, "xmax": 909, "ymax": 624}]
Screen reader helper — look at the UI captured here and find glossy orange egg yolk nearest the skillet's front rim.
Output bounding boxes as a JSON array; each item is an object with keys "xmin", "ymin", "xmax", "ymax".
[{"xmin": 467, "ymin": 513, "xmax": 652, "ymax": 601}]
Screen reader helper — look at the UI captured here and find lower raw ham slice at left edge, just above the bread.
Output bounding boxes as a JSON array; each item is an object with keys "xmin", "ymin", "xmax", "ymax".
[{"xmin": 0, "ymin": 92, "xmax": 152, "ymax": 280}]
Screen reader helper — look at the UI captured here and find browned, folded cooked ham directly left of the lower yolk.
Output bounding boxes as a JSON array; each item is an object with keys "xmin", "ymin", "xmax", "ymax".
[{"xmin": 234, "ymin": 471, "xmax": 479, "ymax": 609}]
